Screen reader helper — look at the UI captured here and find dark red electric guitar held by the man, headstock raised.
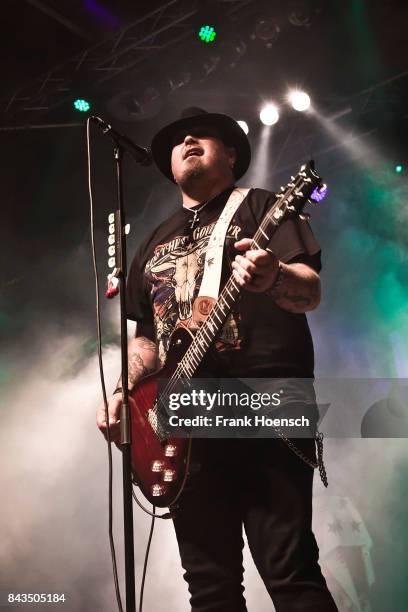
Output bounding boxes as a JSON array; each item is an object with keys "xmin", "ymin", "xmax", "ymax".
[{"xmin": 129, "ymin": 161, "xmax": 326, "ymax": 507}]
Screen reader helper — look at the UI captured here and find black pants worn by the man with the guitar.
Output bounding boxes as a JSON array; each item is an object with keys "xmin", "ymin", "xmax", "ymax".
[{"xmin": 174, "ymin": 438, "xmax": 337, "ymax": 612}]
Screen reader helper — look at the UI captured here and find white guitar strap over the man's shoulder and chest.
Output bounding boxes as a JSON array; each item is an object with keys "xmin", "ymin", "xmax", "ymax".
[{"xmin": 198, "ymin": 187, "xmax": 249, "ymax": 300}]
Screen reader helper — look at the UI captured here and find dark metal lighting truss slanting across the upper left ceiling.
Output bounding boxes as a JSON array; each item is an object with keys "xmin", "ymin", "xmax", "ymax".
[{"xmin": 0, "ymin": 0, "xmax": 255, "ymax": 130}]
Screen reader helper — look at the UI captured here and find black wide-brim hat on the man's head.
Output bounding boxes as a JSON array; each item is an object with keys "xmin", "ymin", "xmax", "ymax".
[{"xmin": 151, "ymin": 107, "xmax": 251, "ymax": 182}]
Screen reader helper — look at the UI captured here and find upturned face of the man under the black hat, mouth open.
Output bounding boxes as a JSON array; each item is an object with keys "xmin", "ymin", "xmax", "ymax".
[{"xmin": 171, "ymin": 125, "xmax": 236, "ymax": 188}]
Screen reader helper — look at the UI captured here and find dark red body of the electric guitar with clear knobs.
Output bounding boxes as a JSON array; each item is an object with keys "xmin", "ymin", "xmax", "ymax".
[{"xmin": 129, "ymin": 328, "xmax": 193, "ymax": 508}]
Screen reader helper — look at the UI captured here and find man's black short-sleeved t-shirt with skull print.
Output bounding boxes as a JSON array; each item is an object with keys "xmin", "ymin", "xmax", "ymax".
[{"xmin": 127, "ymin": 189, "xmax": 321, "ymax": 378}]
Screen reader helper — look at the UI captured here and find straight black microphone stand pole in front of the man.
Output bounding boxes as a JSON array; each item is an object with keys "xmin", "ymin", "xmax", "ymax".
[{"xmin": 113, "ymin": 144, "xmax": 136, "ymax": 612}]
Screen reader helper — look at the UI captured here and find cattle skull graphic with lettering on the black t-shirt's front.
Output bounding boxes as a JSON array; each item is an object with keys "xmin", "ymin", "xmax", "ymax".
[{"xmin": 144, "ymin": 223, "xmax": 241, "ymax": 359}]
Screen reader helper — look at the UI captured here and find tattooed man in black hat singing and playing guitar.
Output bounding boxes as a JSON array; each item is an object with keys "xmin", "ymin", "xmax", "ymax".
[{"xmin": 97, "ymin": 108, "xmax": 337, "ymax": 612}]
